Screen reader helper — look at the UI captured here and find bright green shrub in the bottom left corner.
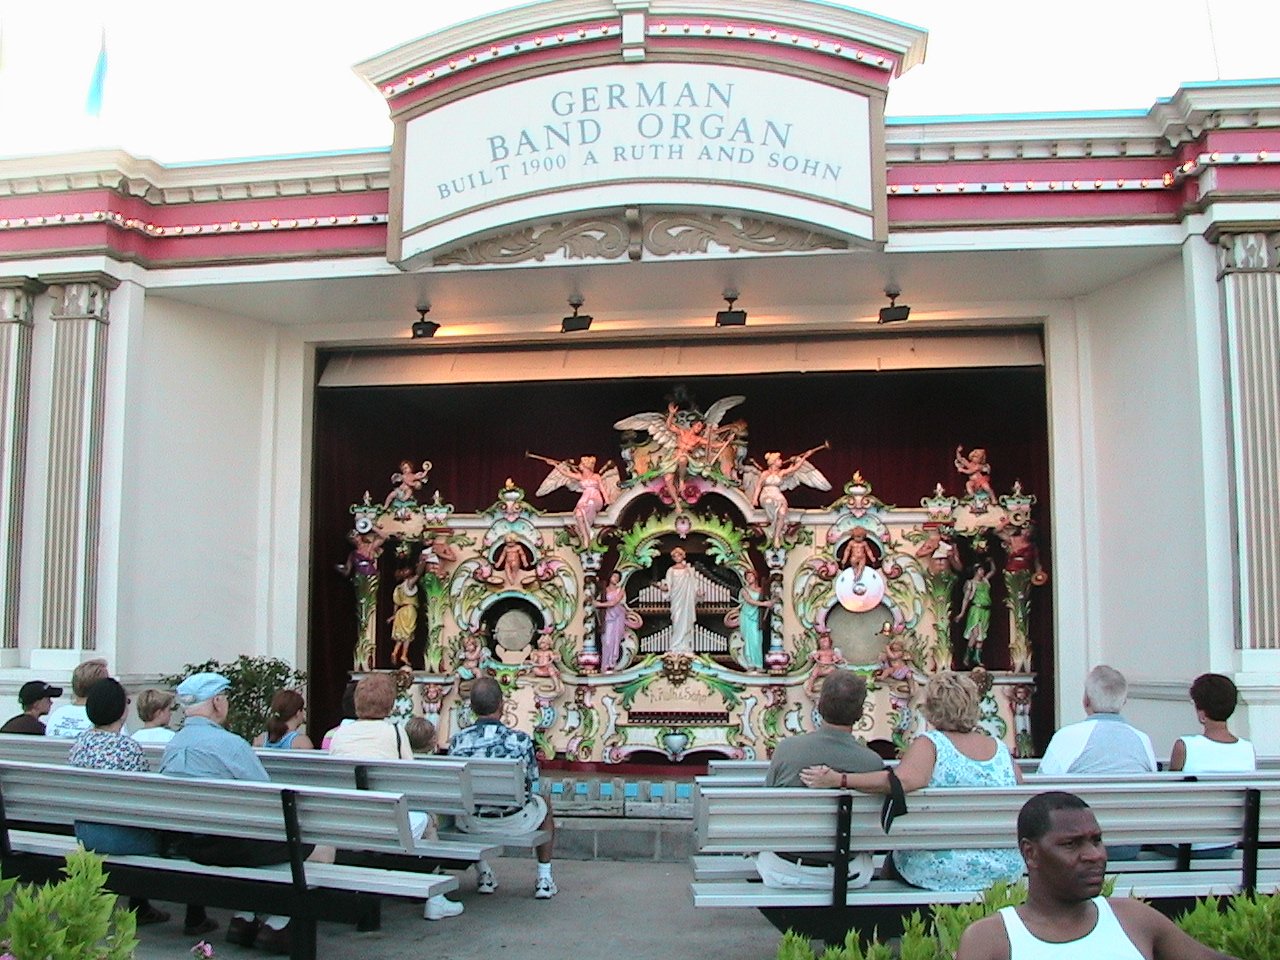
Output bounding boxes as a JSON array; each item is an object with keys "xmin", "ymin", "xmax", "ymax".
[{"xmin": 0, "ymin": 850, "xmax": 138, "ymax": 960}]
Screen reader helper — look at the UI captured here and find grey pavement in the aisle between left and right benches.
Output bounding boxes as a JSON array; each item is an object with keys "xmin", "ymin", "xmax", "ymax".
[{"xmin": 129, "ymin": 856, "xmax": 780, "ymax": 960}]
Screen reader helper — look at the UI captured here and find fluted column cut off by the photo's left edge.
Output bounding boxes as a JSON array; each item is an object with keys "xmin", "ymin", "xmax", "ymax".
[{"xmin": 0, "ymin": 276, "xmax": 45, "ymax": 649}]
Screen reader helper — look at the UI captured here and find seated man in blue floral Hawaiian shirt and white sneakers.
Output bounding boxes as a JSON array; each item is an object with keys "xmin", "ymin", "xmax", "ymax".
[{"xmin": 449, "ymin": 677, "xmax": 559, "ymax": 900}]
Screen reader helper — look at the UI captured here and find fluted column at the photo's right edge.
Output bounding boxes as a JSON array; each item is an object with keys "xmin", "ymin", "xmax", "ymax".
[{"xmin": 1219, "ymin": 232, "xmax": 1280, "ymax": 650}]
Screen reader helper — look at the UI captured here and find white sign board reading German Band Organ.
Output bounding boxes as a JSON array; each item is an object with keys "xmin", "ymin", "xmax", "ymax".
[{"xmin": 401, "ymin": 63, "xmax": 874, "ymax": 260}]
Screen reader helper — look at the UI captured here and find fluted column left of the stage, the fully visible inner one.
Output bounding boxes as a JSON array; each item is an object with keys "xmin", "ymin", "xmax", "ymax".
[{"xmin": 40, "ymin": 274, "xmax": 119, "ymax": 650}]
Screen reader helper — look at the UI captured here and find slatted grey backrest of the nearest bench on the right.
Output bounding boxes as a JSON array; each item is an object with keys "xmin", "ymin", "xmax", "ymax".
[{"xmin": 694, "ymin": 777, "xmax": 1248, "ymax": 852}]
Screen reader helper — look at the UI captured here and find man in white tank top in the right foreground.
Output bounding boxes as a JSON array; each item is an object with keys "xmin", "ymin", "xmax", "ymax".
[{"xmin": 956, "ymin": 791, "xmax": 1233, "ymax": 960}]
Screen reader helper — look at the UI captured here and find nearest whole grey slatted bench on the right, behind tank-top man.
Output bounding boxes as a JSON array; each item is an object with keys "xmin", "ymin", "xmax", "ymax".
[{"xmin": 692, "ymin": 777, "xmax": 1280, "ymax": 940}]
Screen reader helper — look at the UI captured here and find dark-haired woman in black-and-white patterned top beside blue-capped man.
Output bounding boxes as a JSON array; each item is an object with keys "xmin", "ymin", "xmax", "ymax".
[{"xmin": 67, "ymin": 677, "xmax": 218, "ymax": 936}]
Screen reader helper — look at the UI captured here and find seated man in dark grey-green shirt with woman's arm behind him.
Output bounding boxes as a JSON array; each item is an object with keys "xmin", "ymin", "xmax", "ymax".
[{"xmin": 755, "ymin": 671, "xmax": 884, "ymax": 890}]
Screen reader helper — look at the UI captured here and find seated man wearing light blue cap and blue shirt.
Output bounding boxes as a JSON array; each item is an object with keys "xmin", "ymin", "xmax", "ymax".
[{"xmin": 160, "ymin": 673, "xmax": 311, "ymax": 954}]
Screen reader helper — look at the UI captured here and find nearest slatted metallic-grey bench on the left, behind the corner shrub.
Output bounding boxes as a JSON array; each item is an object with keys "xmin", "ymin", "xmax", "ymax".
[{"xmin": 0, "ymin": 760, "xmax": 458, "ymax": 960}]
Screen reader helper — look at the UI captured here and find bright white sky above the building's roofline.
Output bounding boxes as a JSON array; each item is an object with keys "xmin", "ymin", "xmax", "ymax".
[{"xmin": 0, "ymin": 0, "xmax": 1280, "ymax": 163}]
